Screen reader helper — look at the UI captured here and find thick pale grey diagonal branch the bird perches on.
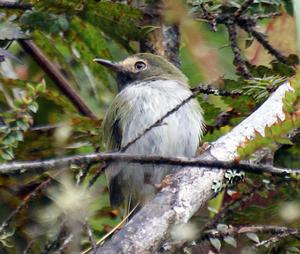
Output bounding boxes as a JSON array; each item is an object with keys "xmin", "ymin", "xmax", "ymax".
[{"xmin": 97, "ymin": 82, "xmax": 293, "ymax": 254}]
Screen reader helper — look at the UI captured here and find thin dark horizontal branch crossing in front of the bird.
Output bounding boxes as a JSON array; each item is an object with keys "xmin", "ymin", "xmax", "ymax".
[{"xmin": 0, "ymin": 153, "xmax": 300, "ymax": 176}]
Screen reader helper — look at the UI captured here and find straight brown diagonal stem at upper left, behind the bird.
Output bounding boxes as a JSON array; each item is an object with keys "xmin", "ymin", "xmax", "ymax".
[{"xmin": 18, "ymin": 40, "xmax": 97, "ymax": 119}]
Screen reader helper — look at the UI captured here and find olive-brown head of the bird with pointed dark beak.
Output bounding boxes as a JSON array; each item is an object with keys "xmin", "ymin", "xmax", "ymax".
[{"xmin": 94, "ymin": 53, "xmax": 187, "ymax": 90}]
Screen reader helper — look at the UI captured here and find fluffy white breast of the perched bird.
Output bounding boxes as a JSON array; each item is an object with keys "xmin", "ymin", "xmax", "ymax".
[{"xmin": 119, "ymin": 80, "xmax": 203, "ymax": 156}]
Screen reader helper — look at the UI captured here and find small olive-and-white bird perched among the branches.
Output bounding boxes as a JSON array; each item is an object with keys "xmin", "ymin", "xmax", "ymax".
[{"xmin": 94, "ymin": 53, "xmax": 204, "ymax": 212}]
